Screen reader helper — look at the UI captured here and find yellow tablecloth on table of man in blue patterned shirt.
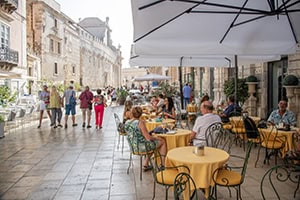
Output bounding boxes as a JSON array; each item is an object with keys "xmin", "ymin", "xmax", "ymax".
[{"xmin": 259, "ymin": 128, "xmax": 296, "ymax": 157}]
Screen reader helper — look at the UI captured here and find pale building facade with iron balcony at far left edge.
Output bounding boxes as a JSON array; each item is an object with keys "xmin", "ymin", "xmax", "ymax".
[{"xmin": 0, "ymin": 0, "xmax": 27, "ymax": 96}]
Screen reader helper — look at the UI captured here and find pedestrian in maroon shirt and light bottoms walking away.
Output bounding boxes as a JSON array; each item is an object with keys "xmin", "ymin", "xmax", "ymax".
[{"xmin": 79, "ymin": 86, "xmax": 94, "ymax": 128}]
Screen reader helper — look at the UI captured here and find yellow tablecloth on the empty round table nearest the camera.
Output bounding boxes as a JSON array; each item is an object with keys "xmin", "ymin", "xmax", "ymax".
[{"xmin": 166, "ymin": 146, "xmax": 229, "ymax": 197}]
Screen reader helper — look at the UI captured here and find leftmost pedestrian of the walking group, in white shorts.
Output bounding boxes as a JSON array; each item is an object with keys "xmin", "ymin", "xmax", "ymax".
[{"xmin": 37, "ymin": 85, "xmax": 51, "ymax": 128}]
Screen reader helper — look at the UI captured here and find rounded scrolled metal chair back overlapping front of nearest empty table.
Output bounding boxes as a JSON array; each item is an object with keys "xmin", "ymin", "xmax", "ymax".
[{"xmin": 173, "ymin": 172, "xmax": 198, "ymax": 200}]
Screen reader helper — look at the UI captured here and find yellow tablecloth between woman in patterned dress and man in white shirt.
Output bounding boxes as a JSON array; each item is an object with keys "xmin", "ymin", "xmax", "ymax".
[{"xmin": 156, "ymin": 129, "xmax": 192, "ymax": 151}]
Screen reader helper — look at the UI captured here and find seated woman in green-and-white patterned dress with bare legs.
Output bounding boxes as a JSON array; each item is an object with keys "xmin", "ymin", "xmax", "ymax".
[{"xmin": 125, "ymin": 106, "xmax": 167, "ymax": 171}]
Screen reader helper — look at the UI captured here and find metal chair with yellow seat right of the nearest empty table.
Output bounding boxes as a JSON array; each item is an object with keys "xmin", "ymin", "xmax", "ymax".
[{"xmin": 211, "ymin": 142, "xmax": 253, "ymax": 199}]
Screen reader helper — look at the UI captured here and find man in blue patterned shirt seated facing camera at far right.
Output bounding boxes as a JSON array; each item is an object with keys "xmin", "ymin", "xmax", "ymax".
[{"xmin": 268, "ymin": 100, "xmax": 297, "ymax": 126}]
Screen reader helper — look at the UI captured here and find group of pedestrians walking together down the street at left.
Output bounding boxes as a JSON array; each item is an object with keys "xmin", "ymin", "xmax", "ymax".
[{"xmin": 37, "ymin": 84, "xmax": 117, "ymax": 129}]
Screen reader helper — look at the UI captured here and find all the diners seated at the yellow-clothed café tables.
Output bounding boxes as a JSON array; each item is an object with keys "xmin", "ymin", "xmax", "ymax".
[{"xmin": 123, "ymin": 91, "xmax": 300, "ymax": 171}]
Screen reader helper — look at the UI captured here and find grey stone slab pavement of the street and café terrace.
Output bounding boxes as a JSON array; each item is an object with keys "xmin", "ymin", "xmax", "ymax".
[{"xmin": 0, "ymin": 106, "xmax": 300, "ymax": 200}]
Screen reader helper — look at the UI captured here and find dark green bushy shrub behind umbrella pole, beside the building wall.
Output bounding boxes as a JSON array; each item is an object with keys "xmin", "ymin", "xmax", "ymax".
[{"xmin": 224, "ymin": 79, "xmax": 249, "ymax": 103}]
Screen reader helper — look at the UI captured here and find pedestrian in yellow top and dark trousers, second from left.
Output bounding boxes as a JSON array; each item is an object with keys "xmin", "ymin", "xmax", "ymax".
[{"xmin": 49, "ymin": 85, "xmax": 62, "ymax": 128}]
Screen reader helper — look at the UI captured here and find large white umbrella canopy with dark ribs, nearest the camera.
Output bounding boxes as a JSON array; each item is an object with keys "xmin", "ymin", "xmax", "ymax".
[{"xmin": 131, "ymin": 0, "xmax": 300, "ymax": 58}]
